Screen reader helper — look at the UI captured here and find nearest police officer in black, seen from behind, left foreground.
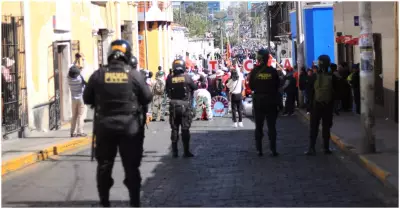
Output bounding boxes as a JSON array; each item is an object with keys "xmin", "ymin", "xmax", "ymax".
[{"xmin": 83, "ymin": 40, "xmax": 152, "ymax": 207}]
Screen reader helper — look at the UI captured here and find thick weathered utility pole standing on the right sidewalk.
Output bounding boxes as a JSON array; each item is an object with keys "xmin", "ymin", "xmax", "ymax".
[{"xmin": 358, "ymin": 2, "xmax": 376, "ymax": 153}]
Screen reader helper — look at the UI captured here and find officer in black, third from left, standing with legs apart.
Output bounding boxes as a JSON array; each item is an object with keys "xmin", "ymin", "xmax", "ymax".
[{"xmin": 249, "ymin": 49, "xmax": 280, "ymax": 156}]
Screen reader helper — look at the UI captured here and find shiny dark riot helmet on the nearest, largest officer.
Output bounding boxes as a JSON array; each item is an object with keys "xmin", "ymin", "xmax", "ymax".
[{"xmin": 107, "ymin": 39, "xmax": 132, "ymax": 64}]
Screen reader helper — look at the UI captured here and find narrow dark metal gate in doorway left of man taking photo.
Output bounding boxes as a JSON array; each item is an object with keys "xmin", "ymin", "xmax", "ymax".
[{"xmin": 49, "ymin": 42, "xmax": 61, "ymax": 130}]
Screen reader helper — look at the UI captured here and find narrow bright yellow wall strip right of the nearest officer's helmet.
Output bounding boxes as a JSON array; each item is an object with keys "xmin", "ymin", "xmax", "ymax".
[{"xmin": 147, "ymin": 22, "xmax": 160, "ymax": 75}]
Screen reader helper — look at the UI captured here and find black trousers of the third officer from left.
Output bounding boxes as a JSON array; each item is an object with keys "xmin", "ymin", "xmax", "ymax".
[{"xmin": 253, "ymin": 94, "xmax": 278, "ymax": 152}]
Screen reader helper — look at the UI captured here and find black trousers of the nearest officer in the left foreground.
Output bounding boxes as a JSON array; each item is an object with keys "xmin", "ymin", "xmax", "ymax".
[{"xmin": 95, "ymin": 115, "xmax": 144, "ymax": 207}]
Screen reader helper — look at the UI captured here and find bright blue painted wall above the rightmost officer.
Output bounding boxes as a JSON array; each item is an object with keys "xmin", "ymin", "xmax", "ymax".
[{"xmin": 303, "ymin": 7, "xmax": 335, "ymax": 67}]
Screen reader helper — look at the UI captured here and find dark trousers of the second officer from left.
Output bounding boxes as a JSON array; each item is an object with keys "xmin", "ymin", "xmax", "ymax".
[{"xmin": 169, "ymin": 101, "xmax": 192, "ymax": 149}]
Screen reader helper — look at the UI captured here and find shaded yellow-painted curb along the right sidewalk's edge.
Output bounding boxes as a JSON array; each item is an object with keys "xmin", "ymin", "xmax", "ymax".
[{"xmin": 298, "ymin": 110, "xmax": 398, "ymax": 191}]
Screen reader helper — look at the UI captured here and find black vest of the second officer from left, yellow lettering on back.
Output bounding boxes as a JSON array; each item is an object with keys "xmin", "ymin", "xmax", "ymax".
[{"xmin": 168, "ymin": 74, "xmax": 190, "ymax": 101}]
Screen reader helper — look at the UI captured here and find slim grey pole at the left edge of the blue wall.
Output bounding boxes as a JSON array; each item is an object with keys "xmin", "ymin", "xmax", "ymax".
[{"xmin": 296, "ymin": 1, "xmax": 304, "ymax": 106}]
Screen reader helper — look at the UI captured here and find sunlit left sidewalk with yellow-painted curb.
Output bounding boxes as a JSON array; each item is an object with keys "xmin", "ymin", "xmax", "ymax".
[{"xmin": 1, "ymin": 122, "xmax": 92, "ymax": 175}]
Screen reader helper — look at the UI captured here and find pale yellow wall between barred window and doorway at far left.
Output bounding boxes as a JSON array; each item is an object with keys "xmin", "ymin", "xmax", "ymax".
[{"xmin": 27, "ymin": 1, "xmax": 56, "ymax": 105}]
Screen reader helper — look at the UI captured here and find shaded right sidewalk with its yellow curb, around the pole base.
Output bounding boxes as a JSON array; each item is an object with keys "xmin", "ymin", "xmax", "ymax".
[{"xmin": 300, "ymin": 110, "xmax": 399, "ymax": 190}]
